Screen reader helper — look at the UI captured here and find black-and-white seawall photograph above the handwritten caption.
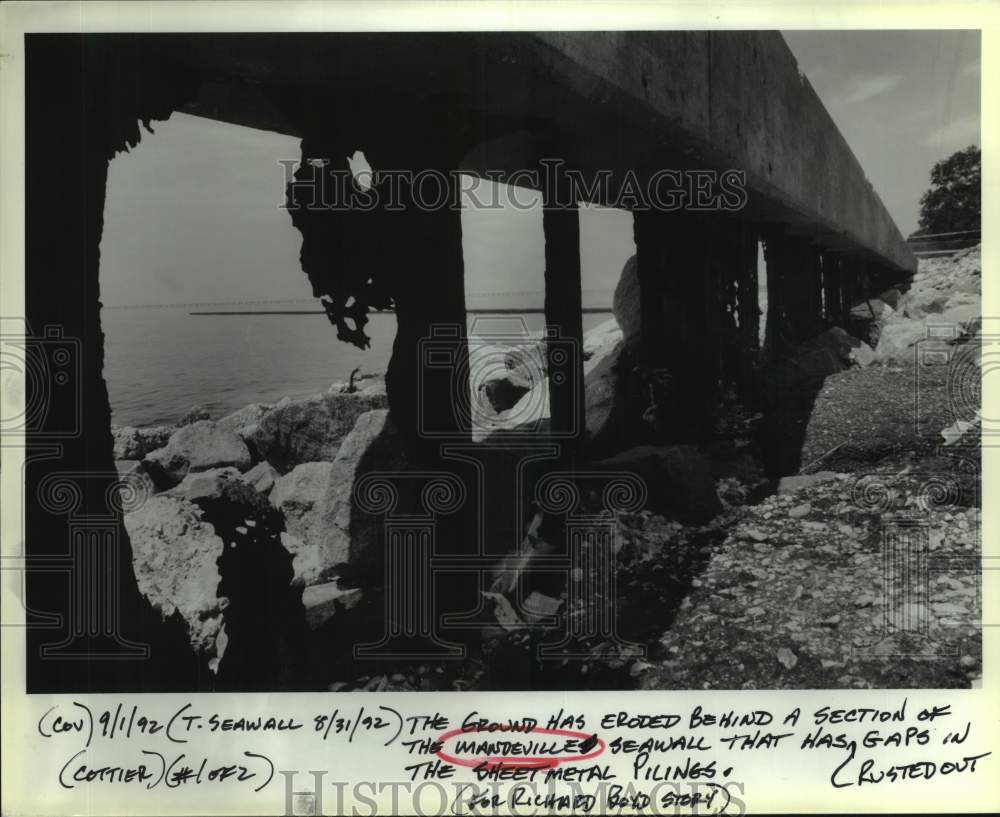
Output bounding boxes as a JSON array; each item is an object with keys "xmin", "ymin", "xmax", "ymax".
[{"xmin": 0, "ymin": 3, "xmax": 995, "ymax": 814}]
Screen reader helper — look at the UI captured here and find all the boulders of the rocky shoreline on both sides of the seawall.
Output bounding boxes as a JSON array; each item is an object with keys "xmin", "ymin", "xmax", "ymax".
[{"xmin": 112, "ymin": 248, "xmax": 980, "ymax": 688}]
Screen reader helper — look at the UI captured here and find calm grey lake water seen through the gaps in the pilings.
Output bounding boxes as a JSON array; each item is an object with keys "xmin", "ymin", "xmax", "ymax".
[{"xmin": 101, "ymin": 307, "xmax": 609, "ymax": 426}]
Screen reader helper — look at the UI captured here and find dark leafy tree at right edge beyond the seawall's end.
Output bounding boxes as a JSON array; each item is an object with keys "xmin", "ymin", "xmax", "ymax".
[{"xmin": 916, "ymin": 145, "xmax": 981, "ymax": 235}]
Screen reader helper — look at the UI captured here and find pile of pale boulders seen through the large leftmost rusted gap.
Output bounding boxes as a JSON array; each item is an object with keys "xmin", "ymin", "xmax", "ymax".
[{"xmin": 112, "ymin": 374, "xmax": 392, "ymax": 672}]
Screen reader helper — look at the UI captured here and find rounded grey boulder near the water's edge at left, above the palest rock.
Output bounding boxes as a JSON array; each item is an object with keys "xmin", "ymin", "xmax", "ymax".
[{"xmin": 143, "ymin": 420, "xmax": 251, "ymax": 487}]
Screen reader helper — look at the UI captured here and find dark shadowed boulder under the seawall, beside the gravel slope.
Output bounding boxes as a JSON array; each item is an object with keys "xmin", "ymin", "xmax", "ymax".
[{"xmin": 594, "ymin": 445, "xmax": 722, "ymax": 524}]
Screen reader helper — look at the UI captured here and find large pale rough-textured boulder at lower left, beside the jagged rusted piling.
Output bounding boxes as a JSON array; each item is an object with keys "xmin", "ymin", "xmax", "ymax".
[{"xmin": 125, "ymin": 494, "xmax": 227, "ymax": 668}]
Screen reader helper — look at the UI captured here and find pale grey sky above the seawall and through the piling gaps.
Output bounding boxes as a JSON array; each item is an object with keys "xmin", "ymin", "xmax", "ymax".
[{"xmin": 101, "ymin": 31, "xmax": 980, "ymax": 306}]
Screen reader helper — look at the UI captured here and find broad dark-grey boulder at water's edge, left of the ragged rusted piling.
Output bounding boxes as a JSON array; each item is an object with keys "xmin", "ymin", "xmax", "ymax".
[{"xmin": 250, "ymin": 392, "xmax": 388, "ymax": 472}]
